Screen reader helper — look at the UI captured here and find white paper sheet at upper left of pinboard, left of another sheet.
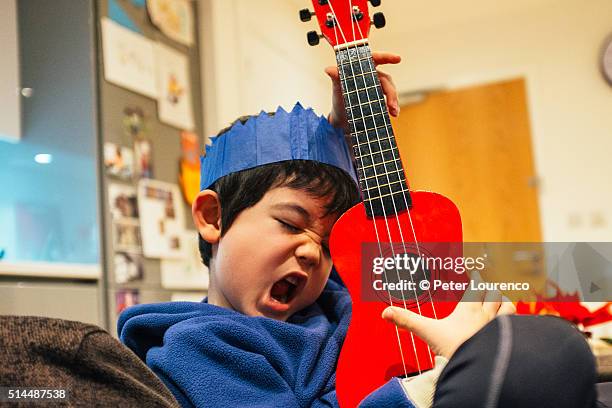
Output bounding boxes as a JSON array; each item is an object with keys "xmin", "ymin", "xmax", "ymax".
[{"xmin": 101, "ymin": 17, "xmax": 157, "ymax": 98}]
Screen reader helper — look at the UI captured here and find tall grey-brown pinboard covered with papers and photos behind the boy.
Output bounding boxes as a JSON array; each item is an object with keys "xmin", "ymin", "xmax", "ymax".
[{"xmin": 97, "ymin": 0, "xmax": 207, "ymax": 328}]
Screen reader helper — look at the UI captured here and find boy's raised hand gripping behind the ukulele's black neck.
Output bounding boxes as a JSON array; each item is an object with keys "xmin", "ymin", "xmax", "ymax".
[{"xmin": 325, "ymin": 52, "xmax": 402, "ymax": 128}]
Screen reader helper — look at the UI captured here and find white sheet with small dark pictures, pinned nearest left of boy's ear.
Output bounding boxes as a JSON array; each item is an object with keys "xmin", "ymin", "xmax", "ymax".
[{"xmin": 138, "ymin": 179, "xmax": 185, "ymax": 259}]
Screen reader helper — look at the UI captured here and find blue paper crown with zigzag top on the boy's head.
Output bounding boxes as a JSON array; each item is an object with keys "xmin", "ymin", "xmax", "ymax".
[{"xmin": 200, "ymin": 103, "xmax": 357, "ymax": 190}]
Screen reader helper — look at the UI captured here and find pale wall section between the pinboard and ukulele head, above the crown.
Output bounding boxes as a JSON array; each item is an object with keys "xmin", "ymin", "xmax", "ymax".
[{"xmin": 199, "ymin": 0, "xmax": 335, "ymax": 136}]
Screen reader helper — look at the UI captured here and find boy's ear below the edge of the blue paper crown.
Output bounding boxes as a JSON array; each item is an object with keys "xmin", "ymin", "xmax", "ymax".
[{"xmin": 191, "ymin": 190, "xmax": 221, "ymax": 244}]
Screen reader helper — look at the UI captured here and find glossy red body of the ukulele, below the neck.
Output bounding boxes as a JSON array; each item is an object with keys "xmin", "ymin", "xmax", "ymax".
[{"xmin": 330, "ymin": 191, "xmax": 467, "ymax": 407}]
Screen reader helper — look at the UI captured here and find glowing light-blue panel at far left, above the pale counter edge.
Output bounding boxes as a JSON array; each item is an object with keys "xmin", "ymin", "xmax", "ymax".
[{"xmin": 0, "ymin": 142, "xmax": 99, "ymax": 263}]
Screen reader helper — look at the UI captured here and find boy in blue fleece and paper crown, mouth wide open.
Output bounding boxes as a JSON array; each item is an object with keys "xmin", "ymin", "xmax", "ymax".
[{"xmin": 118, "ymin": 56, "xmax": 596, "ymax": 407}]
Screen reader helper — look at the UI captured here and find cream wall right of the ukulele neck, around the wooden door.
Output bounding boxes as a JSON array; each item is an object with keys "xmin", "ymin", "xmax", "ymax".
[{"xmin": 374, "ymin": 0, "xmax": 612, "ymax": 241}]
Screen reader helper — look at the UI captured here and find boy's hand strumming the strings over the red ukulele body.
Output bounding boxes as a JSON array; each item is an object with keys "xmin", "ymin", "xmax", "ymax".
[{"xmin": 382, "ymin": 276, "xmax": 516, "ymax": 359}]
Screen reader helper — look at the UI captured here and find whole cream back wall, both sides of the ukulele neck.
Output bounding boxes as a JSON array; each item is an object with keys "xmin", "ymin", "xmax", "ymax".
[{"xmin": 200, "ymin": 0, "xmax": 612, "ymax": 241}]
